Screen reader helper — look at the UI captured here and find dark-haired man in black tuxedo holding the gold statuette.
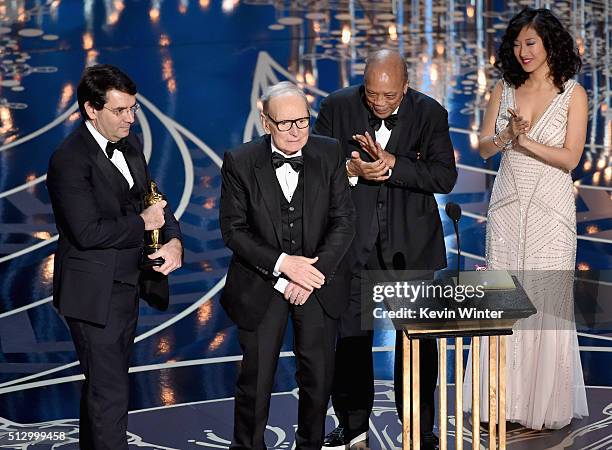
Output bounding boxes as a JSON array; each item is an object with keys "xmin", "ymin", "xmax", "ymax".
[{"xmin": 47, "ymin": 65, "xmax": 182, "ymax": 450}]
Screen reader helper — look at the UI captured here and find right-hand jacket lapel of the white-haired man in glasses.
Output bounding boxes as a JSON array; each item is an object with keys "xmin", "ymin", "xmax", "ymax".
[{"xmin": 302, "ymin": 140, "xmax": 323, "ymax": 249}]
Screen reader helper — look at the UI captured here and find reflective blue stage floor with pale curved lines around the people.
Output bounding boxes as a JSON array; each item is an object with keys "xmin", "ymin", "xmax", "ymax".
[{"xmin": 0, "ymin": 0, "xmax": 612, "ymax": 450}]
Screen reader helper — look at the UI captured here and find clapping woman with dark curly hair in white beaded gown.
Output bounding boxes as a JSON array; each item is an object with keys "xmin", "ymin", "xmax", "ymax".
[{"xmin": 464, "ymin": 8, "xmax": 588, "ymax": 430}]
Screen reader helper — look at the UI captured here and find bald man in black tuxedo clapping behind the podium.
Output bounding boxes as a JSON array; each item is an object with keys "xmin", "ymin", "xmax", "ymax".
[{"xmin": 313, "ymin": 50, "xmax": 457, "ymax": 450}]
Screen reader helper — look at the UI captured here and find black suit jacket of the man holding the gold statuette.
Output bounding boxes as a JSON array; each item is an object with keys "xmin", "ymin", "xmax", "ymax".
[{"xmin": 47, "ymin": 122, "xmax": 181, "ymax": 325}]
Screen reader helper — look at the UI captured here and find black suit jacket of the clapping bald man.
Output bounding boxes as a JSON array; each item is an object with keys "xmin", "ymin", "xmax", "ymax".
[{"xmin": 313, "ymin": 86, "xmax": 457, "ymax": 270}]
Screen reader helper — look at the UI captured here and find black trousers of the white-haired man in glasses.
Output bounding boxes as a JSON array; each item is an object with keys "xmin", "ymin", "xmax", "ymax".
[{"xmin": 230, "ymin": 294, "xmax": 337, "ymax": 450}]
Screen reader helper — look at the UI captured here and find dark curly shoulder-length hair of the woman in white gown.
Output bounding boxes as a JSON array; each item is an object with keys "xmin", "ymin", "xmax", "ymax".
[{"xmin": 495, "ymin": 7, "xmax": 582, "ymax": 93}]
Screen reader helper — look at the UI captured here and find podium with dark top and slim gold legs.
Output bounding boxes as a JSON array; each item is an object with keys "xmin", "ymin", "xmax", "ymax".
[{"xmin": 385, "ymin": 276, "xmax": 536, "ymax": 450}]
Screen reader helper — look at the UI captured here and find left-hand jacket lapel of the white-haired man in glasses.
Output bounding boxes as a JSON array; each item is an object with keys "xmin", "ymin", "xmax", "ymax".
[{"xmin": 255, "ymin": 135, "xmax": 282, "ymax": 247}]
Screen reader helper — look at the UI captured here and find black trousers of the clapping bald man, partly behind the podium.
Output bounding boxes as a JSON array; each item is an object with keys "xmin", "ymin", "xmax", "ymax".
[{"xmin": 332, "ymin": 245, "xmax": 438, "ymax": 434}]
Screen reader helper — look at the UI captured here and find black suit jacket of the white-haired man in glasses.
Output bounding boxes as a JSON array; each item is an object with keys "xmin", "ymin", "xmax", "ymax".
[{"xmin": 219, "ymin": 135, "xmax": 354, "ymax": 330}]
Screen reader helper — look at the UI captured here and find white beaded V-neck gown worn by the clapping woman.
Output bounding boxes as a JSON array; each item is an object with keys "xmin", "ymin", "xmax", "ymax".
[{"xmin": 463, "ymin": 80, "xmax": 588, "ymax": 430}]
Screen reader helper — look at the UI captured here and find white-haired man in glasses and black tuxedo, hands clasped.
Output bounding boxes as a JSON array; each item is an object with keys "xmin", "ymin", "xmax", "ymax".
[{"xmin": 219, "ymin": 82, "xmax": 354, "ymax": 450}]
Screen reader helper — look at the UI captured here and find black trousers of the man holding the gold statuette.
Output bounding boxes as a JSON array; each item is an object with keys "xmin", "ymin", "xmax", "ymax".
[{"xmin": 66, "ymin": 283, "xmax": 138, "ymax": 450}]
